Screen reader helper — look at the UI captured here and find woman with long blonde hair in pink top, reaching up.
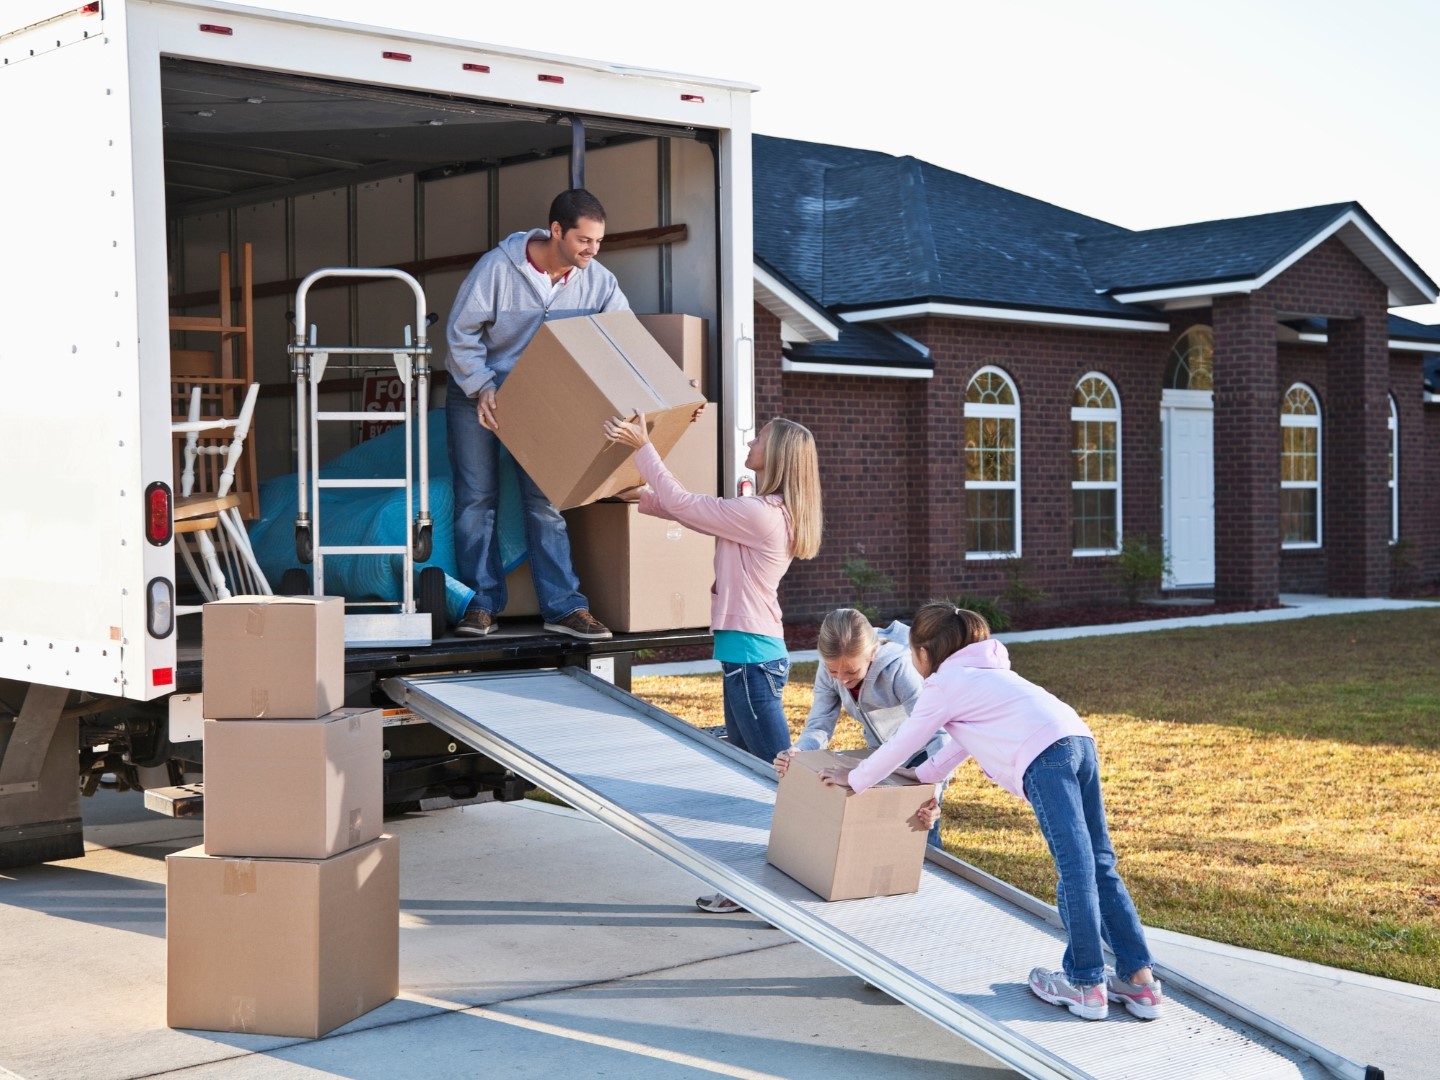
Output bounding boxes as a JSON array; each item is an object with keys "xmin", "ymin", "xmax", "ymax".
[{"xmin": 605, "ymin": 415, "xmax": 822, "ymax": 913}]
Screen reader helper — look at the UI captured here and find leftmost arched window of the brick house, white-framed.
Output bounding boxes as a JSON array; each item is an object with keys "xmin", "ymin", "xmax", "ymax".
[{"xmin": 965, "ymin": 367, "xmax": 1020, "ymax": 557}]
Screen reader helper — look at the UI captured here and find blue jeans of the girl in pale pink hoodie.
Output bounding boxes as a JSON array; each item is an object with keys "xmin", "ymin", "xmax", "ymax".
[{"xmin": 1025, "ymin": 736, "xmax": 1151, "ymax": 986}]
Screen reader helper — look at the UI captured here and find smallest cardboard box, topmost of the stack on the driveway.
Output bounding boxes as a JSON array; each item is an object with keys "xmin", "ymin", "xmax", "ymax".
[{"xmin": 200, "ymin": 596, "xmax": 346, "ymax": 720}]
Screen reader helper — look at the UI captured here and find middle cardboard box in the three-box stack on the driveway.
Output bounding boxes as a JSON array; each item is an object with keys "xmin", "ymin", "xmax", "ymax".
[{"xmin": 204, "ymin": 708, "xmax": 384, "ymax": 858}]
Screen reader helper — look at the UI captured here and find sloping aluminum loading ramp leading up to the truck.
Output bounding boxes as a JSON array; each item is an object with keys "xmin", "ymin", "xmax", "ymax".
[{"xmin": 386, "ymin": 668, "xmax": 1382, "ymax": 1080}]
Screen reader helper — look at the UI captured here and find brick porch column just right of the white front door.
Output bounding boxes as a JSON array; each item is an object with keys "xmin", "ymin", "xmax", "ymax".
[{"xmin": 1212, "ymin": 294, "xmax": 1280, "ymax": 605}]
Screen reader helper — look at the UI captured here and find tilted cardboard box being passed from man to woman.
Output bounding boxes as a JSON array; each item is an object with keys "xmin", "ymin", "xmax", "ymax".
[{"xmin": 495, "ymin": 311, "xmax": 704, "ymax": 510}]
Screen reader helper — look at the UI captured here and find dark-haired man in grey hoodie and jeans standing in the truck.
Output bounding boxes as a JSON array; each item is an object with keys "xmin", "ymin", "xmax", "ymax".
[{"xmin": 445, "ymin": 187, "xmax": 629, "ymax": 641}]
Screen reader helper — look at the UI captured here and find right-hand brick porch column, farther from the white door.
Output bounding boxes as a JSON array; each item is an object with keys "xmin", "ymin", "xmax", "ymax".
[{"xmin": 1320, "ymin": 308, "xmax": 1390, "ymax": 596}]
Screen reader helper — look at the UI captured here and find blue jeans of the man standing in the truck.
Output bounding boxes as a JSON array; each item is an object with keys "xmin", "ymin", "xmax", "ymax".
[{"xmin": 445, "ymin": 379, "xmax": 590, "ymax": 622}]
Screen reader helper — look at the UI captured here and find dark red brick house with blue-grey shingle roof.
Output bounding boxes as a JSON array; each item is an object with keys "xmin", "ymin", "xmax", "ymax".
[{"xmin": 755, "ymin": 137, "xmax": 1440, "ymax": 619}]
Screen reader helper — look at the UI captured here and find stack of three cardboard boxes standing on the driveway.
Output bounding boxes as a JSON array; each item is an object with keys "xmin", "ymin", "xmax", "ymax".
[{"xmin": 166, "ymin": 596, "xmax": 400, "ymax": 1038}]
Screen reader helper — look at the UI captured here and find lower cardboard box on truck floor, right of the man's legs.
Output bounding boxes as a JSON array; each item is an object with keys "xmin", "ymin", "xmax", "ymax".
[{"xmin": 564, "ymin": 503, "xmax": 716, "ymax": 634}]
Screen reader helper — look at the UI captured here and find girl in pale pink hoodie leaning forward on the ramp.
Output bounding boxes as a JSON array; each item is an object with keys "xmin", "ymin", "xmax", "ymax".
[{"xmin": 822, "ymin": 602, "xmax": 1162, "ymax": 1020}]
